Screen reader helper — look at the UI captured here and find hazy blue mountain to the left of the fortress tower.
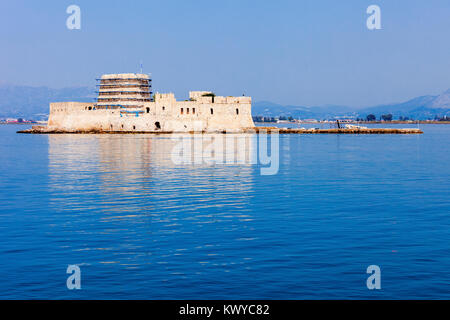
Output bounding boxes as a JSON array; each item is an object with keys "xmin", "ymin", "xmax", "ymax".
[{"xmin": 0, "ymin": 84, "xmax": 96, "ymax": 119}]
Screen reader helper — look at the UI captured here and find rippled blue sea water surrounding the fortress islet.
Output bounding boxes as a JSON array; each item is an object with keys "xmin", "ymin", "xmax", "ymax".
[{"xmin": 0, "ymin": 125, "xmax": 450, "ymax": 299}]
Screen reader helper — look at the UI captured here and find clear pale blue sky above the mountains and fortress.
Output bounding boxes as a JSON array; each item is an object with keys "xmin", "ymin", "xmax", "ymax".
[{"xmin": 0, "ymin": 0, "xmax": 450, "ymax": 107}]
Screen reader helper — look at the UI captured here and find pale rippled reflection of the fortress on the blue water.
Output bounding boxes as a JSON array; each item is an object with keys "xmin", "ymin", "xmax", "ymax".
[{"xmin": 48, "ymin": 134, "xmax": 256, "ymax": 211}]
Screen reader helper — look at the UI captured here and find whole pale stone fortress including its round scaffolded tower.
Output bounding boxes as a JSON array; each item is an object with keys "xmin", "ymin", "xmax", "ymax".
[{"xmin": 46, "ymin": 73, "xmax": 255, "ymax": 132}]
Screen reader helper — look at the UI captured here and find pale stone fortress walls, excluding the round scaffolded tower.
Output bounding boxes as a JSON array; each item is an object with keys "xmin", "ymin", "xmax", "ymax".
[{"xmin": 48, "ymin": 94, "xmax": 254, "ymax": 132}]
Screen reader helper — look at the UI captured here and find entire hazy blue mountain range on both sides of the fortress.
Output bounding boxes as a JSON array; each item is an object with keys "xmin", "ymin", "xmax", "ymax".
[{"xmin": 0, "ymin": 84, "xmax": 450, "ymax": 120}]
